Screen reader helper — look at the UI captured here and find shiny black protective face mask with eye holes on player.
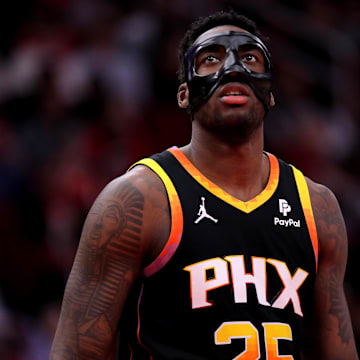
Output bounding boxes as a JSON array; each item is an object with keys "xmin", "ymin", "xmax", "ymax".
[{"xmin": 185, "ymin": 31, "xmax": 272, "ymax": 113}]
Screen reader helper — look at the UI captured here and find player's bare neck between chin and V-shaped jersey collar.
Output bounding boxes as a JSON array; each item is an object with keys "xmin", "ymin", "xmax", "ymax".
[{"xmin": 181, "ymin": 126, "xmax": 270, "ymax": 201}]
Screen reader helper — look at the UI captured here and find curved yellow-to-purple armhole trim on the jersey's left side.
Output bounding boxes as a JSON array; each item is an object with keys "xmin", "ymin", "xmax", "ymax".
[{"xmin": 128, "ymin": 158, "xmax": 184, "ymax": 277}]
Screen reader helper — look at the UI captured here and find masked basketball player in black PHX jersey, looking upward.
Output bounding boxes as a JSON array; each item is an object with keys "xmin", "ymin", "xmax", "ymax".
[{"xmin": 51, "ymin": 12, "xmax": 358, "ymax": 360}]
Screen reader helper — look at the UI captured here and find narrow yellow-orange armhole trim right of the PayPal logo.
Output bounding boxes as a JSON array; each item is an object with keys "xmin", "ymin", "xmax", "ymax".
[{"xmin": 291, "ymin": 165, "xmax": 319, "ymax": 271}]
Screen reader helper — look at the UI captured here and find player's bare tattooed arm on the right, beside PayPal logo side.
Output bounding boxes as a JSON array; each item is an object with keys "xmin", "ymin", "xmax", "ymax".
[{"xmin": 304, "ymin": 180, "xmax": 358, "ymax": 360}]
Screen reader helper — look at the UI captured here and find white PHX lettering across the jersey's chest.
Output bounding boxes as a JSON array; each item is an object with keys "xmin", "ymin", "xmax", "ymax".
[{"xmin": 184, "ymin": 255, "xmax": 309, "ymax": 316}]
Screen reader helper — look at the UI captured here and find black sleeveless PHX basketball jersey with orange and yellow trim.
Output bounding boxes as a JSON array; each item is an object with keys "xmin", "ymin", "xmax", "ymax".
[{"xmin": 119, "ymin": 147, "xmax": 318, "ymax": 360}]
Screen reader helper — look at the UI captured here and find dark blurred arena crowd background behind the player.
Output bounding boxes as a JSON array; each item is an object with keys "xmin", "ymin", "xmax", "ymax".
[{"xmin": 0, "ymin": 0, "xmax": 360, "ymax": 360}]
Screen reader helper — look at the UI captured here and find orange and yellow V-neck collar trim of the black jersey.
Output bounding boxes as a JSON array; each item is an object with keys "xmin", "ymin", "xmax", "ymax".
[{"xmin": 168, "ymin": 146, "xmax": 280, "ymax": 214}]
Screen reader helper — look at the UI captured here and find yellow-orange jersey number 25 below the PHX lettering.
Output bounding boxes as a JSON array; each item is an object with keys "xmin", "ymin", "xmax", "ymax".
[{"xmin": 215, "ymin": 321, "xmax": 294, "ymax": 360}]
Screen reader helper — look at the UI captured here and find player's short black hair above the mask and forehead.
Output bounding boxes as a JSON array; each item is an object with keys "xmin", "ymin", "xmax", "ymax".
[{"xmin": 178, "ymin": 9, "xmax": 268, "ymax": 83}]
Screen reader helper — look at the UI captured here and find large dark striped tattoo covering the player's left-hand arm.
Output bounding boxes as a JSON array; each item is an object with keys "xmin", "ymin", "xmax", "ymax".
[{"xmin": 54, "ymin": 182, "xmax": 144, "ymax": 359}]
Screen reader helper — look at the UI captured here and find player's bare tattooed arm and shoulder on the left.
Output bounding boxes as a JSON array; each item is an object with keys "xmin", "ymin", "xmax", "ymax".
[{"xmin": 50, "ymin": 167, "xmax": 168, "ymax": 360}]
